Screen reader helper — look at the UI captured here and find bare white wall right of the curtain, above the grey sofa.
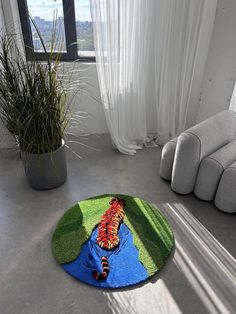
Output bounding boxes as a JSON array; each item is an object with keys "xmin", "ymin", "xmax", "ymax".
[{"xmin": 197, "ymin": 0, "xmax": 236, "ymax": 122}]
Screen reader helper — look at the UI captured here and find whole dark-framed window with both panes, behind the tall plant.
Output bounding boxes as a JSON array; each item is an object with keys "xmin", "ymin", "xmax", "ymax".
[{"xmin": 18, "ymin": 0, "xmax": 95, "ymax": 62}]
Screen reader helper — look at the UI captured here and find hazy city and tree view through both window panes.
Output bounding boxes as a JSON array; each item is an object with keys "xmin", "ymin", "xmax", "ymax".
[{"xmin": 27, "ymin": 0, "xmax": 95, "ymax": 56}]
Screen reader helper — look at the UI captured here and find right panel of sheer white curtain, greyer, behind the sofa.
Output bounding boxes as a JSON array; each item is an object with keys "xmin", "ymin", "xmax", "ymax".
[{"xmin": 153, "ymin": 0, "xmax": 217, "ymax": 142}]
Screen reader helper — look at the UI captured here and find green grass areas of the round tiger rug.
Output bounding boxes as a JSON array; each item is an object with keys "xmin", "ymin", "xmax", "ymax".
[{"xmin": 52, "ymin": 194, "xmax": 174, "ymax": 276}]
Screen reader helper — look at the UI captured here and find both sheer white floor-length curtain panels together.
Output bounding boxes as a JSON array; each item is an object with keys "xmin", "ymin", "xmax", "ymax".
[{"xmin": 90, "ymin": 0, "xmax": 217, "ymax": 154}]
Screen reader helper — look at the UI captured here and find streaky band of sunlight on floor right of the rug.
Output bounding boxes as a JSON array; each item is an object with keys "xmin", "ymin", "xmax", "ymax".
[{"xmin": 160, "ymin": 203, "xmax": 236, "ymax": 313}]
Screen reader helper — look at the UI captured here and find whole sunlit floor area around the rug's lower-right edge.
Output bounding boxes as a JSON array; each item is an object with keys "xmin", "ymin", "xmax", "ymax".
[{"xmin": 103, "ymin": 203, "xmax": 236, "ymax": 314}]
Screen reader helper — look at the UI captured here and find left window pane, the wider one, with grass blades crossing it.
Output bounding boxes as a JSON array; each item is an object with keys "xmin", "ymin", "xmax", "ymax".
[{"xmin": 27, "ymin": 0, "xmax": 66, "ymax": 51}]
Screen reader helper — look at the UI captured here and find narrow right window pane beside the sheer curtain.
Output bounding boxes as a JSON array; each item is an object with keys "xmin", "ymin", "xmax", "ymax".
[{"xmin": 75, "ymin": 0, "xmax": 95, "ymax": 57}]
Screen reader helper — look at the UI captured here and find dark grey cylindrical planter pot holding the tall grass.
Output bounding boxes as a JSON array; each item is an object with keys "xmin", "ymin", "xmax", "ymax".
[{"xmin": 21, "ymin": 141, "xmax": 67, "ymax": 190}]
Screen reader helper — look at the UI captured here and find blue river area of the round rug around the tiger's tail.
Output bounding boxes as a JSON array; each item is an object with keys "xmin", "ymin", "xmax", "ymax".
[{"xmin": 62, "ymin": 223, "xmax": 148, "ymax": 288}]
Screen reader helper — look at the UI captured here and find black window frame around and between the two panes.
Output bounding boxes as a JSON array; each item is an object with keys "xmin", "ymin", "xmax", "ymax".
[{"xmin": 17, "ymin": 0, "xmax": 96, "ymax": 62}]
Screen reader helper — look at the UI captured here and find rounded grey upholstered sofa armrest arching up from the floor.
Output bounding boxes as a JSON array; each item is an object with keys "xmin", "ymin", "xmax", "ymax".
[{"xmin": 171, "ymin": 110, "xmax": 236, "ymax": 194}]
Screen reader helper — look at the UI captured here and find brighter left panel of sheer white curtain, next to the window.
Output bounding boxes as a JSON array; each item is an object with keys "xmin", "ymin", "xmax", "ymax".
[{"xmin": 90, "ymin": 0, "xmax": 148, "ymax": 154}]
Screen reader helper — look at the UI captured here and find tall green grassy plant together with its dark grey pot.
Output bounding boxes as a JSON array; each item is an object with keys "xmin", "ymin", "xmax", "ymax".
[{"xmin": 0, "ymin": 25, "xmax": 78, "ymax": 190}]
